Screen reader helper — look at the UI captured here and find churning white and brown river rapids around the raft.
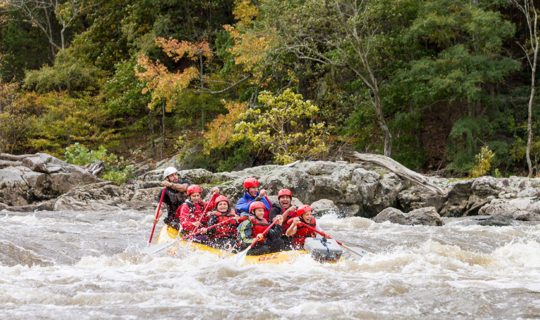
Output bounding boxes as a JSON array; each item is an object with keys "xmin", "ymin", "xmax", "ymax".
[{"xmin": 0, "ymin": 211, "xmax": 540, "ymax": 320}]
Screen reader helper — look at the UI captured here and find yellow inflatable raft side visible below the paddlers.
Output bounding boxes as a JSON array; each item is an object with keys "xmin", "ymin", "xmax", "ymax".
[{"xmin": 156, "ymin": 225, "xmax": 309, "ymax": 264}]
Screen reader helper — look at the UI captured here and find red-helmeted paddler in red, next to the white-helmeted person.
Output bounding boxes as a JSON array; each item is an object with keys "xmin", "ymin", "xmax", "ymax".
[{"xmin": 176, "ymin": 184, "xmax": 219, "ymax": 242}]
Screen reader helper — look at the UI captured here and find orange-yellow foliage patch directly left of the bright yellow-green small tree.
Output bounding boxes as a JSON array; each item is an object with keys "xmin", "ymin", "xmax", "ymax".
[{"xmin": 204, "ymin": 102, "xmax": 247, "ymax": 153}]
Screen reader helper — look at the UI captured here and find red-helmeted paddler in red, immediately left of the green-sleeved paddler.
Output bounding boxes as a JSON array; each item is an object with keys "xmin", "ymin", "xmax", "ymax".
[{"xmin": 208, "ymin": 195, "xmax": 245, "ymax": 250}]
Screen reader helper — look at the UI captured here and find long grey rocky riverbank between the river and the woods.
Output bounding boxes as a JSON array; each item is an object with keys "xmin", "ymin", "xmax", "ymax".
[{"xmin": 0, "ymin": 154, "xmax": 540, "ymax": 225}]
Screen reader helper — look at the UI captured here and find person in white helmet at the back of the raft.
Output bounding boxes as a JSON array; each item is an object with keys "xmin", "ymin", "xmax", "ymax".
[{"xmin": 159, "ymin": 167, "xmax": 190, "ymax": 231}]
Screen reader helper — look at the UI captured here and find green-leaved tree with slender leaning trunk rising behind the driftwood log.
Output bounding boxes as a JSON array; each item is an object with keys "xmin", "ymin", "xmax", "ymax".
[{"xmin": 258, "ymin": 0, "xmax": 392, "ymax": 156}]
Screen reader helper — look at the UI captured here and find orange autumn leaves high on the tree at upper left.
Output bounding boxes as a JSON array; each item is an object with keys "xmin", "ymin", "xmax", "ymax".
[{"xmin": 135, "ymin": 37, "xmax": 212, "ymax": 112}]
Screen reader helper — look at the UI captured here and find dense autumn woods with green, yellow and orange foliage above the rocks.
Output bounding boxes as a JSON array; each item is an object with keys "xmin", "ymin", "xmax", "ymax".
[{"xmin": 0, "ymin": 0, "xmax": 540, "ymax": 176}]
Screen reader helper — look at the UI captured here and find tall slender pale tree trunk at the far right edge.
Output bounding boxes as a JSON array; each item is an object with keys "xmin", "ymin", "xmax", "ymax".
[{"xmin": 511, "ymin": 0, "xmax": 540, "ymax": 177}]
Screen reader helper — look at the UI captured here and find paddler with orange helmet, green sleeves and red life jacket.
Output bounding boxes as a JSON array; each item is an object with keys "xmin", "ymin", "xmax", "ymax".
[{"xmin": 238, "ymin": 201, "xmax": 283, "ymax": 255}]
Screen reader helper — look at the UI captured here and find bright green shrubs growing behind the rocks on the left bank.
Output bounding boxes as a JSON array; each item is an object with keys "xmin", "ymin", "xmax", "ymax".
[{"xmin": 64, "ymin": 143, "xmax": 135, "ymax": 184}]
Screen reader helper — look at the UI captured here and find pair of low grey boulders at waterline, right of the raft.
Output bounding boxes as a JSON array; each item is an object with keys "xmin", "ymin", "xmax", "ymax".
[{"xmin": 373, "ymin": 207, "xmax": 443, "ymax": 226}]
